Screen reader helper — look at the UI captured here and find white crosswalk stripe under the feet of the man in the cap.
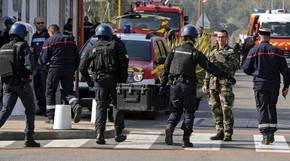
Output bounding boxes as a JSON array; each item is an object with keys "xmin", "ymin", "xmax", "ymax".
[{"xmin": 254, "ymin": 135, "xmax": 290, "ymax": 153}]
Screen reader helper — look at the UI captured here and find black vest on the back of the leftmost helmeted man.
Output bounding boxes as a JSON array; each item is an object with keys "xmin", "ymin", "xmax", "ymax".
[{"xmin": 0, "ymin": 42, "xmax": 24, "ymax": 78}]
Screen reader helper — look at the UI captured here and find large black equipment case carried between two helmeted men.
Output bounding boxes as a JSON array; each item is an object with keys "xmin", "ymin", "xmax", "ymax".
[{"xmin": 117, "ymin": 84, "xmax": 169, "ymax": 111}]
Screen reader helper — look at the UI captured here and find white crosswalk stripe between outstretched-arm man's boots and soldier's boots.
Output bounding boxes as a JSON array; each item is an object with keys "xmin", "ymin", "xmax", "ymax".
[{"xmin": 184, "ymin": 133, "xmax": 222, "ymax": 151}]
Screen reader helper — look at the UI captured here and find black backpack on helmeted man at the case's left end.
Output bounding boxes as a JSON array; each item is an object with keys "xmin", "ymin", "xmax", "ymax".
[{"xmin": 93, "ymin": 41, "xmax": 119, "ymax": 87}]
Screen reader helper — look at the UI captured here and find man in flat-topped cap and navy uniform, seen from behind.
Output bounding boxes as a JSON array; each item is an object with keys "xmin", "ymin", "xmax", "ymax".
[{"xmin": 242, "ymin": 28, "xmax": 289, "ymax": 145}]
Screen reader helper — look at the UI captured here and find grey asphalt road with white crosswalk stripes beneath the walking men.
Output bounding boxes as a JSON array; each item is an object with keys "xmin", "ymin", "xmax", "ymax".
[{"xmin": 0, "ymin": 73, "xmax": 290, "ymax": 161}]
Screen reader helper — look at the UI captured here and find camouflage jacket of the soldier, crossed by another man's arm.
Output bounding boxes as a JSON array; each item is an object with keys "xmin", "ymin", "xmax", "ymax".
[{"xmin": 204, "ymin": 46, "xmax": 240, "ymax": 90}]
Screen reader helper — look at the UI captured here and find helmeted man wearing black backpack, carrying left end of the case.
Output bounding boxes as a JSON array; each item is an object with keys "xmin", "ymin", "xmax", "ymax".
[{"xmin": 80, "ymin": 24, "xmax": 128, "ymax": 144}]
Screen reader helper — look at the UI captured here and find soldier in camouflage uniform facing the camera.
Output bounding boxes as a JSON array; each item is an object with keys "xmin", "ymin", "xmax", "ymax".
[{"xmin": 203, "ymin": 30, "xmax": 239, "ymax": 141}]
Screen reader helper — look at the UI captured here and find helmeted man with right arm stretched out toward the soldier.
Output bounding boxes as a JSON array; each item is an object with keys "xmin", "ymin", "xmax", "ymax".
[{"xmin": 160, "ymin": 25, "xmax": 235, "ymax": 147}]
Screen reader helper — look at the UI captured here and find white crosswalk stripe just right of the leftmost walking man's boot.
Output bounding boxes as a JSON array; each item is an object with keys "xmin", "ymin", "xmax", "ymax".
[{"xmin": 43, "ymin": 139, "xmax": 89, "ymax": 148}]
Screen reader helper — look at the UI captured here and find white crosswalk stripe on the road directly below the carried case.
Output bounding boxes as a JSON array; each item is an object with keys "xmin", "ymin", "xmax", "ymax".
[{"xmin": 114, "ymin": 132, "xmax": 161, "ymax": 149}]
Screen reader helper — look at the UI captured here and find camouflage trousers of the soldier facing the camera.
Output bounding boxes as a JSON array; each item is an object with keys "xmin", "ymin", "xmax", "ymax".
[{"xmin": 209, "ymin": 88, "xmax": 235, "ymax": 136}]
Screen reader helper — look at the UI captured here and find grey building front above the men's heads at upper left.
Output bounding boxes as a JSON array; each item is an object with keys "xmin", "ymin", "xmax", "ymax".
[{"xmin": 0, "ymin": 0, "xmax": 76, "ymax": 32}]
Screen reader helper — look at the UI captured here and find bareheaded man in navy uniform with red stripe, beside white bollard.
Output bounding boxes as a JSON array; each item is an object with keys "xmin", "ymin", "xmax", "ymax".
[{"xmin": 39, "ymin": 24, "xmax": 82, "ymax": 123}]
